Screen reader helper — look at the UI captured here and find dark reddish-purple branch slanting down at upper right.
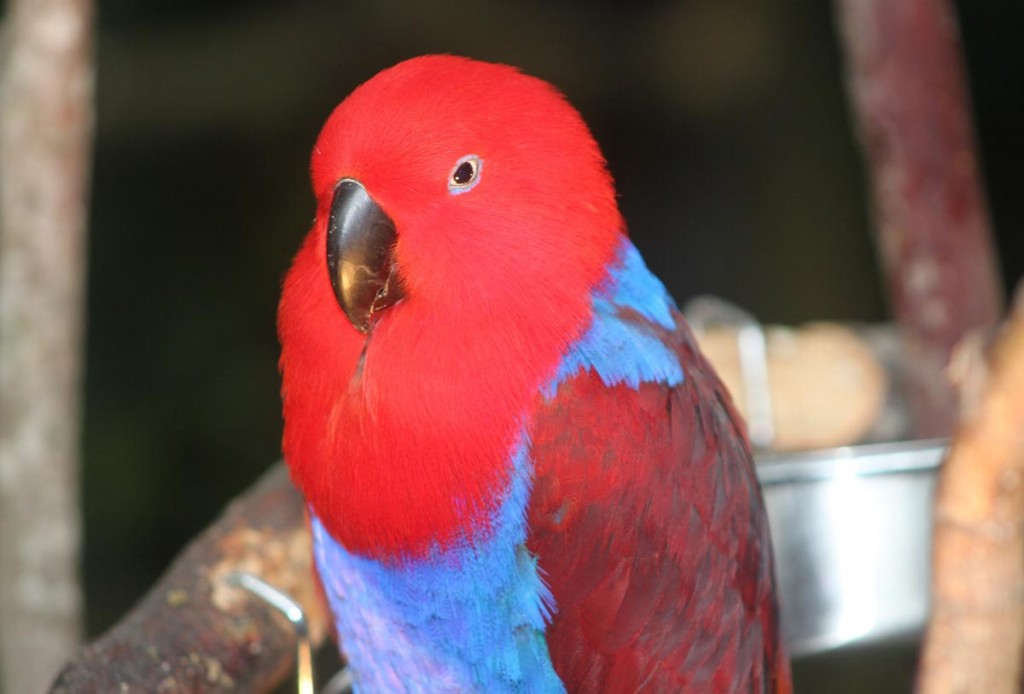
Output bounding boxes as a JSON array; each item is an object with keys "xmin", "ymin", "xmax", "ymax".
[{"xmin": 835, "ymin": 0, "xmax": 1001, "ymax": 437}]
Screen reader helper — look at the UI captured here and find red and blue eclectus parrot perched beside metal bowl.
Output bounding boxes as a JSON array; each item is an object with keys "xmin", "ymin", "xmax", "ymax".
[{"xmin": 279, "ymin": 55, "xmax": 790, "ymax": 693}]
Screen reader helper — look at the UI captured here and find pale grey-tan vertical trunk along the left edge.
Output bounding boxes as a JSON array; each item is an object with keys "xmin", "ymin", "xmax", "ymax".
[{"xmin": 0, "ymin": 0, "xmax": 93, "ymax": 693}]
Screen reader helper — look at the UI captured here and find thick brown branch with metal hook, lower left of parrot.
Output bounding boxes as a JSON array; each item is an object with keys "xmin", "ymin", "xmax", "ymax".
[{"xmin": 51, "ymin": 465, "xmax": 326, "ymax": 694}]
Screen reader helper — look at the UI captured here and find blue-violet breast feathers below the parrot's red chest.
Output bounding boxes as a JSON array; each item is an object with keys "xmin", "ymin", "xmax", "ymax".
[{"xmin": 312, "ymin": 443, "xmax": 564, "ymax": 693}]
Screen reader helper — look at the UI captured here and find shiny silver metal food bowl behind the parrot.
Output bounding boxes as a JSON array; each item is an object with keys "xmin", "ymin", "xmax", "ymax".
[{"xmin": 757, "ymin": 440, "xmax": 947, "ymax": 657}]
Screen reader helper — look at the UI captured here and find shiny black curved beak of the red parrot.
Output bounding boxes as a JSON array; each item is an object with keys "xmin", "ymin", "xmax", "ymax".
[{"xmin": 327, "ymin": 178, "xmax": 402, "ymax": 333}]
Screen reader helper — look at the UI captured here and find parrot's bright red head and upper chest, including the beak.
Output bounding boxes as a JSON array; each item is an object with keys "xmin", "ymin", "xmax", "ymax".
[{"xmin": 279, "ymin": 55, "xmax": 623, "ymax": 557}]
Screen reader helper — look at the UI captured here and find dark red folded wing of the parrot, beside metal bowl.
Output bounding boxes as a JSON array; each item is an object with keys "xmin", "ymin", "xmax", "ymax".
[{"xmin": 527, "ymin": 305, "xmax": 788, "ymax": 692}]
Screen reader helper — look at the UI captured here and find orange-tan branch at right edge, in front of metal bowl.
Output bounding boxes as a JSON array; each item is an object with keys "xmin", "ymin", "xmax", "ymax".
[{"xmin": 919, "ymin": 283, "xmax": 1024, "ymax": 694}]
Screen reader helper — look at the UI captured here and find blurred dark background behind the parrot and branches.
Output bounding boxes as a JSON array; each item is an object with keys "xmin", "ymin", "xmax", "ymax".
[{"xmin": 83, "ymin": 0, "xmax": 1024, "ymax": 659}]
